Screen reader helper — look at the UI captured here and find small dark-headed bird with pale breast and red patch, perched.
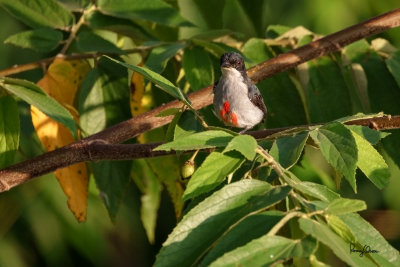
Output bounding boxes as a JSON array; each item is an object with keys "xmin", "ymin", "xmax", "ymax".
[{"xmin": 213, "ymin": 52, "xmax": 267, "ymax": 134}]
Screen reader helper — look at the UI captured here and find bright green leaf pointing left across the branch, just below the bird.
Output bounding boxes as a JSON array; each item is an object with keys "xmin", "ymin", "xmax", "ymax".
[{"xmin": 154, "ymin": 130, "xmax": 233, "ymax": 151}]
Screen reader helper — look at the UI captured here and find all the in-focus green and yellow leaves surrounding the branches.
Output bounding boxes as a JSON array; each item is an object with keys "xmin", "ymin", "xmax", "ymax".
[{"xmin": 0, "ymin": 0, "xmax": 400, "ymax": 266}]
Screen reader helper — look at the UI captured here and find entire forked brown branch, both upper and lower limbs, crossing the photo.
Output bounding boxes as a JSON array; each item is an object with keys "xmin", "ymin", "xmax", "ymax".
[{"xmin": 0, "ymin": 9, "xmax": 400, "ymax": 192}]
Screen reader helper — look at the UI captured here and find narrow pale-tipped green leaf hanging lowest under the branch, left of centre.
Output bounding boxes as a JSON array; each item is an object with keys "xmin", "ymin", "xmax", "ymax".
[{"xmin": 131, "ymin": 159, "xmax": 162, "ymax": 244}]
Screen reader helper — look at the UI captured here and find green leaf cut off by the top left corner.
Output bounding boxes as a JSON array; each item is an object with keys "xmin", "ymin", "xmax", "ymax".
[{"xmin": 0, "ymin": 0, "xmax": 74, "ymax": 28}]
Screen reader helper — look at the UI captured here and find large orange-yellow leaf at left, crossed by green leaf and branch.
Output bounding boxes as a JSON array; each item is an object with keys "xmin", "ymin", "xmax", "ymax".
[{"xmin": 31, "ymin": 59, "xmax": 90, "ymax": 222}]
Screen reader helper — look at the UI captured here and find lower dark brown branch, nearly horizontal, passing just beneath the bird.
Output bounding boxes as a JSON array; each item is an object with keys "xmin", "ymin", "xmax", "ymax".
[{"xmin": 0, "ymin": 116, "xmax": 400, "ymax": 192}]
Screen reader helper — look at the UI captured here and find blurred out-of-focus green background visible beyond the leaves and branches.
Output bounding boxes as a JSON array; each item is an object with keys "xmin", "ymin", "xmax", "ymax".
[{"xmin": 0, "ymin": 0, "xmax": 400, "ymax": 266}]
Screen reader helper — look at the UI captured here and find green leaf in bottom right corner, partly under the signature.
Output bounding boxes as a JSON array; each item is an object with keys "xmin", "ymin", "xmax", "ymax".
[{"xmin": 339, "ymin": 213, "xmax": 400, "ymax": 266}]
